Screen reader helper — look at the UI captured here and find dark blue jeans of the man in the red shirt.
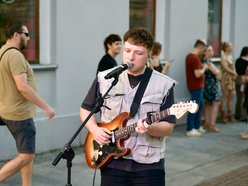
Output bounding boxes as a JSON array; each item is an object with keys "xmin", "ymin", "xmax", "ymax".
[{"xmin": 187, "ymin": 88, "xmax": 203, "ymax": 131}]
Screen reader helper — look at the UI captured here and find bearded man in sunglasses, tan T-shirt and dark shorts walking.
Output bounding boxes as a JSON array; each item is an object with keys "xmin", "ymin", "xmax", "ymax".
[{"xmin": 0, "ymin": 21, "xmax": 55, "ymax": 186}]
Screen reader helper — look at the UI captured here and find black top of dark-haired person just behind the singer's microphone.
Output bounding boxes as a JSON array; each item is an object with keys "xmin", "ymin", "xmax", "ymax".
[{"xmin": 96, "ymin": 54, "xmax": 117, "ymax": 73}]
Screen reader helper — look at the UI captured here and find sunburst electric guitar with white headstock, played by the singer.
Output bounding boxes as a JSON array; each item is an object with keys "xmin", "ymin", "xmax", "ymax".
[{"xmin": 84, "ymin": 101, "xmax": 198, "ymax": 169}]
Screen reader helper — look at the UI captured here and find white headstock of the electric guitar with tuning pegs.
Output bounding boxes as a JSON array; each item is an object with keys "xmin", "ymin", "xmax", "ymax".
[{"xmin": 169, "ymin": 101, "xmax": 198, "ymax": 119}]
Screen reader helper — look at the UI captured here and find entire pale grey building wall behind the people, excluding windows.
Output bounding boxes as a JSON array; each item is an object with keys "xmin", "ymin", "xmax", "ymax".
[{"xmin": 0, "ymin": 0, "xmax": 248, "ymax": 160}]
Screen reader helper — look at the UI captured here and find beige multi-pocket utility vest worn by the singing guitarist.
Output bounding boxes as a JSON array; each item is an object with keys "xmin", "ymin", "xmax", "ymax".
[{"xmin": 98, "ymin": 69, "xmax": 176, "ymax": 163}]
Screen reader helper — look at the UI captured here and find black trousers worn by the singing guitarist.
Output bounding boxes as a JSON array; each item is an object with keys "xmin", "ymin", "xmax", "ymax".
[{"xmin": 101, "ymin": 168, "xmax": 165, "ymax": 186}]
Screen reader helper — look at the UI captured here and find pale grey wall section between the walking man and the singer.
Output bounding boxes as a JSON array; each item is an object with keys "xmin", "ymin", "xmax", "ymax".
[{"xmin": 0, "ymin": 0, "xmax": 129, "ymax": 160}]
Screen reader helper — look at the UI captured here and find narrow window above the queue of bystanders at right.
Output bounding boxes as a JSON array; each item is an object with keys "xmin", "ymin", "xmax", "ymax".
[{"xmin": 208, "ymin": 0, "xmax": 222, "ymax": 56}]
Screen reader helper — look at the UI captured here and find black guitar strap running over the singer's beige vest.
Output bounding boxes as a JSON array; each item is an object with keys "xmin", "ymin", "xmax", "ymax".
[{"xmin": 130, "ymin": 68, "xmax": 152, "ymax": 117}]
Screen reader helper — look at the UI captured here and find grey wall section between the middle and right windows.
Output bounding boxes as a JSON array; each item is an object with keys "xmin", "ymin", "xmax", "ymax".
[{"xmin": 156, "ymin": 0, "xmax": 208, "ymax": 124}]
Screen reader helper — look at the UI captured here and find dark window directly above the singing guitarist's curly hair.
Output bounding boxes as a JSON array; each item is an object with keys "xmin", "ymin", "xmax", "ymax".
[{"xmin": 130, "ymin": 0, "xmax": 156, "ymax": 35}]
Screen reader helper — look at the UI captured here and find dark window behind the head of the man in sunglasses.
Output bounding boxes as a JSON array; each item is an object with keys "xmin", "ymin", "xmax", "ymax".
[{"xmin": 0, "ymin": 0, "xmax": 39, "ymax": 63}]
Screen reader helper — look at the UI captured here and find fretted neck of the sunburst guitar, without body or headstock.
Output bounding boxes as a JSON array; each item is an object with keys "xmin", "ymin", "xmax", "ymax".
[{"xmin": 114, "ymin": 109, "xmax": 170, "ymax": 140}]
